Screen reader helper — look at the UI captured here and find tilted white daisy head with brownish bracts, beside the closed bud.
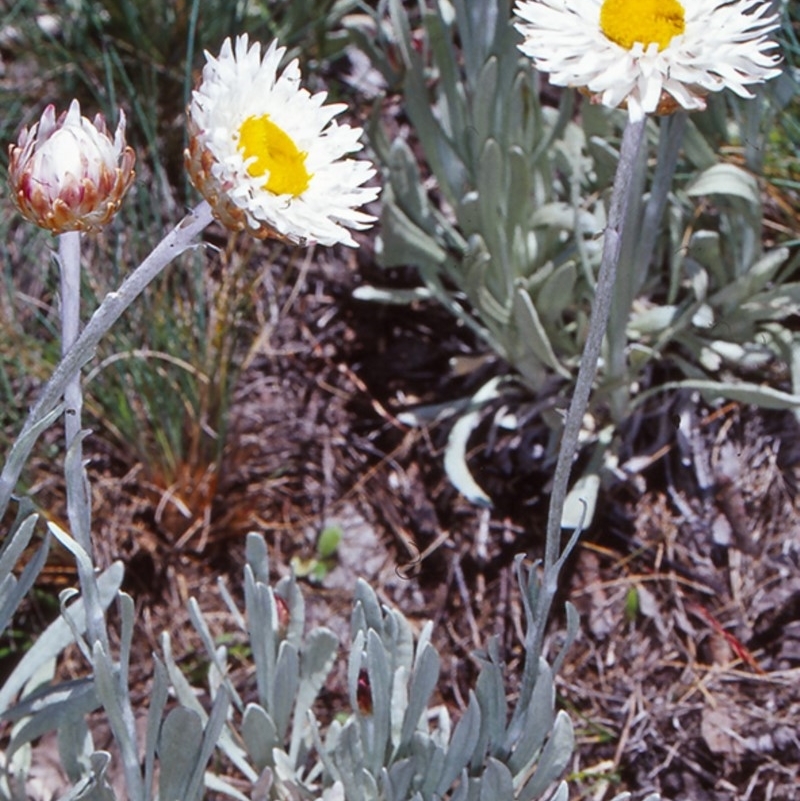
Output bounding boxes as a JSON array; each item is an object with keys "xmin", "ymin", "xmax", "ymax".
[{"xmin": 186, "ymin": 34, "xmax": 379, "ymax": 246}]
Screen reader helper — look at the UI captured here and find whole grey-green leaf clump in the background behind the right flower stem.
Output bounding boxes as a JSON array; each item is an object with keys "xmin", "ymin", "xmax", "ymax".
[{"xmin": 353, "ymin": 0, "xmax": 800, "ymax": 506}]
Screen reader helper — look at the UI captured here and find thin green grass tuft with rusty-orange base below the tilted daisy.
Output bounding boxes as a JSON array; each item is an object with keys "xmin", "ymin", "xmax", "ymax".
[{"xmin": 77, "ymin": 204, "xmax": 290, "ymax": 535}]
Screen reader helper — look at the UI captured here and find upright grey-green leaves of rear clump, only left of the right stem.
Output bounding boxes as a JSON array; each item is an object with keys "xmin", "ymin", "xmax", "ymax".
[{"xmin": 355, "ymin": 0, "xmax": 584, "ymax": 390}]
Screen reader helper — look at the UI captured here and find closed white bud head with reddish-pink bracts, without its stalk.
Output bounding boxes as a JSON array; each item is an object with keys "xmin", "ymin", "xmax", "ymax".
[{"xmin": 8, "ymin": 100, "xmax": 135, "ymax": 234}]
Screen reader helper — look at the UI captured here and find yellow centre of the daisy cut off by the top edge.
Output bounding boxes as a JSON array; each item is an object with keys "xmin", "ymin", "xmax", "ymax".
[{"xmin": 600, "ymin": 0, "xmax": 686, "ymax": 50}]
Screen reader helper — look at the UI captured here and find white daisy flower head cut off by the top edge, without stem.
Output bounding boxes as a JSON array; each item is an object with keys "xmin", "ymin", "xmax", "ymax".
[{"xmin": 515, "ymin": 0, "xmax": 780, "ymax": 121}]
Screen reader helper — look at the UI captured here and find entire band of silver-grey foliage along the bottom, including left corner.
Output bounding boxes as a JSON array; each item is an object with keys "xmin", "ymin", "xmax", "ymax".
[{"xmin": 0, "ymin": 510, "xmax": 664, "ymax": 801}]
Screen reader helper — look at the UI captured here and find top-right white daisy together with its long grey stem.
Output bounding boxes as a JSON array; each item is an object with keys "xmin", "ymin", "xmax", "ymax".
[{"xmin": 515, "ymin": 0, "xmax": 780, "ymax": 656}]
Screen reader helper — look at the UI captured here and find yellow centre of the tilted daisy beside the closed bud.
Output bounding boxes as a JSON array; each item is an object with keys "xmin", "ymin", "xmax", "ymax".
[{"xmin": 239, "ymin": 114, "xmax": 311, "ymax": 197}]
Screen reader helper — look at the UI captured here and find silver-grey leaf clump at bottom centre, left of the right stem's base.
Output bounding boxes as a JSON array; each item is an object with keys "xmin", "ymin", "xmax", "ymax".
[{"xmin": 179, "ymin": 535, "xmax": 575, "ymax": 801}]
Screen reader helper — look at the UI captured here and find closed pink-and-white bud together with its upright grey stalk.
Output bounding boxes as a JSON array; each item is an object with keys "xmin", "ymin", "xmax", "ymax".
[{"xmin": 7, "ymin": 100, "xmax": 135, "ymax": 650}]
